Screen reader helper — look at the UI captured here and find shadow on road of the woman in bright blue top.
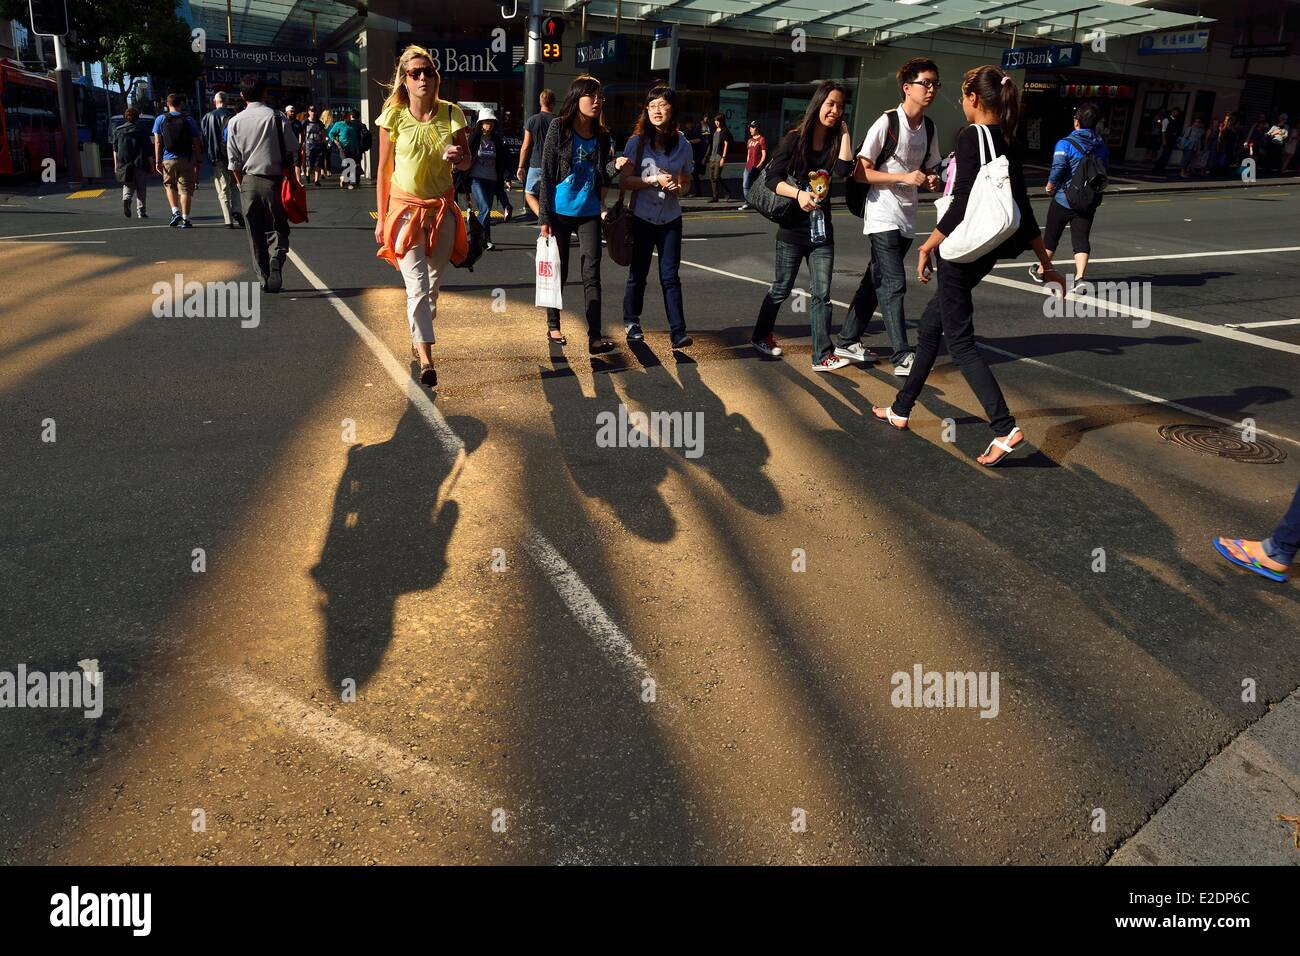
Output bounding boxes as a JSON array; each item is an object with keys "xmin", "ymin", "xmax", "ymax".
[{"xmin": 540, "ymin": 346, "xmax": 677, "ymax": 541}]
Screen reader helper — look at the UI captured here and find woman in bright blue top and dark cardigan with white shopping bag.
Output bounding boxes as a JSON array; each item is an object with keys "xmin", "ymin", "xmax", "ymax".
[{"xmin": 537, "ymin": 75, "xmax": 614, "ymax": 355}]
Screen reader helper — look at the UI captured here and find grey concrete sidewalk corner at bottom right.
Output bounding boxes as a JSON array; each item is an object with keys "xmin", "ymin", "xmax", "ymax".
[{"xmin": 1106, "ymin": 689, "xmax": 1300, "ymax": 866}]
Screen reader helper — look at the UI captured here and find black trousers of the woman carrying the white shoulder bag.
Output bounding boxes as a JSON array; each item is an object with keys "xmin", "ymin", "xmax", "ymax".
[{"xmin": 893, "ymin": 252, "xmax": 1015, "ymax": 437}]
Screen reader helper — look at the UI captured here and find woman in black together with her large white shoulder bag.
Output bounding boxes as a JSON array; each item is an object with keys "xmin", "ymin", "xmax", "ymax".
[{"xmin": 871, "ymin": 66, "xmax": 1065, "ymax": 467}]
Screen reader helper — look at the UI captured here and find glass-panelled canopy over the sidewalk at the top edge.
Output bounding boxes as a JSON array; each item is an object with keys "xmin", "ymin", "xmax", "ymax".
[{"xmin": 546, "ymin": 0, "xmax": 1212, "ymax": 43}]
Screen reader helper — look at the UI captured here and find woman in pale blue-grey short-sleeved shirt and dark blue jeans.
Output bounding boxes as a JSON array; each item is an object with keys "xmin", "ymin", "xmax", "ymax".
[{"xmin": 618, "ymin": 86, "xmax": 694, "ymax": 349}]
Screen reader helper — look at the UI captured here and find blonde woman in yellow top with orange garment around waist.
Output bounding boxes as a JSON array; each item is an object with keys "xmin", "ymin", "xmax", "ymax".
[{"xmin": 374, "ymin": 46, "xmax": 473, "ymax": 388}]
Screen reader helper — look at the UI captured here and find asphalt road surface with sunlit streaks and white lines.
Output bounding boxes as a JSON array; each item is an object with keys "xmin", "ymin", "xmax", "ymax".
[{"xmin": 0, "ymin": 179, "xmax": 1300, "ymax": 864}]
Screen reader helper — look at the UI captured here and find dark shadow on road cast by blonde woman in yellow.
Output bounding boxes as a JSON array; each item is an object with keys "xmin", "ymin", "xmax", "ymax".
[{"xmin": 311, "ymin": 403, "xmax": 486, "ymax": 688}]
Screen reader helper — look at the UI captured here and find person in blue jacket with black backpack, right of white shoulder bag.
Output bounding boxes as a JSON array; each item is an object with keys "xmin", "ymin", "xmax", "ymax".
[{"xmin": 1030, "ymin": 103, "xmax": 1110, "ymax": 294}]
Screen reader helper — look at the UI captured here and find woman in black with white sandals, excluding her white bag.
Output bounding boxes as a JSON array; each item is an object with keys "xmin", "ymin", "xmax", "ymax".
[{"xmin": 871, "ymin": 66, "xmax": 1065, "ymax": 466}]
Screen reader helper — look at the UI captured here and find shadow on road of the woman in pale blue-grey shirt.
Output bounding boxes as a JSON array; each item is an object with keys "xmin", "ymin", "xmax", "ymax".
[{"xmin": 619, "ymin": 342, "xmax": 781, "ymax": 515}]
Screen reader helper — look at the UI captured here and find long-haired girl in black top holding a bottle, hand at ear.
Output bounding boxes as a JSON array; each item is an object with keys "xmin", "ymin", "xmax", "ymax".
[{"xmin": 751, "ymin": 79, "xmax": 853, "ymax": 372}]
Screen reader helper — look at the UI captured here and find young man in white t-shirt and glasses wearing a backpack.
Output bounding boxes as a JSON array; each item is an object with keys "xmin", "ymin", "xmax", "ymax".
[{"xmin": 835, "ymin": 56, "xmax": 941, "ymax": 376}]
